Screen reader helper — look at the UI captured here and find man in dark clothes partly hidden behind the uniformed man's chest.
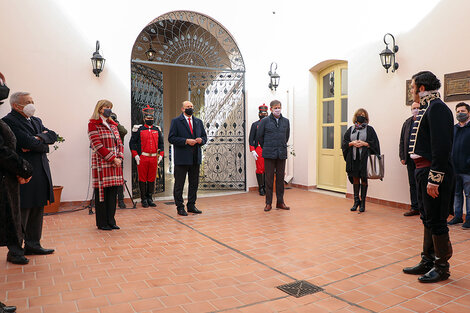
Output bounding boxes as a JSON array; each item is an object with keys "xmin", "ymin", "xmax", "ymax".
[{"xmin": 399, "ymin": 102, "xmax": 420, "ymax": 216}]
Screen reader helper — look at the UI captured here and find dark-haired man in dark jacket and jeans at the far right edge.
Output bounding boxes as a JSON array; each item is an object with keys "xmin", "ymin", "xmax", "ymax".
[{"xmin": 447, "ymin": 102, "xmax": 470, "ymax": 229}]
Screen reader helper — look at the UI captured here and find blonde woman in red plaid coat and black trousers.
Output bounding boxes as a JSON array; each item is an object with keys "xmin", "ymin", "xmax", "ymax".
[{"xmin": 88, "ymin": 100, "xmax": 124, "ymax": 230}]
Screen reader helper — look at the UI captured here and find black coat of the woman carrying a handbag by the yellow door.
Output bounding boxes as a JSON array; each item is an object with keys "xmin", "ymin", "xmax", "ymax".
[{"xmin": 341, "ymin": 125, "xmax": 380, "ymax": 184}]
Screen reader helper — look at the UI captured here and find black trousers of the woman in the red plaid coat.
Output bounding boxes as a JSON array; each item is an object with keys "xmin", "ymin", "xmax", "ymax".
[{"xmin": 95, "ymin": 186, "xmax": 118, "ymax": 227}]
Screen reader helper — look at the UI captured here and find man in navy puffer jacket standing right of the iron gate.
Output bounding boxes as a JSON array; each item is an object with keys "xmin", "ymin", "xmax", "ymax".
[{"xmin": 257, "ymin": 100, "xmax": 290, "ymax": 212}]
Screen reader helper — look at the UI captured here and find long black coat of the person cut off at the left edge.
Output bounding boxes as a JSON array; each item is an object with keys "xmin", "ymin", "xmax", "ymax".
[{"xmin": 0, "ymin": 120, "xmax": 33, "ymax": 246}]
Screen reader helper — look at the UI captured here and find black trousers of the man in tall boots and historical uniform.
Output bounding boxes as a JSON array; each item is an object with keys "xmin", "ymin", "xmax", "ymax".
[{"xmin": 415, "ymin": 166, "xmax": 455, "ymax": 235}]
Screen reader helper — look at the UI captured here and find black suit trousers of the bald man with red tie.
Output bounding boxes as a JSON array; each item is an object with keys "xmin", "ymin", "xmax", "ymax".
[{"xmin": 173, "ymin": 164, "xmax": 199, "ymax": 209}]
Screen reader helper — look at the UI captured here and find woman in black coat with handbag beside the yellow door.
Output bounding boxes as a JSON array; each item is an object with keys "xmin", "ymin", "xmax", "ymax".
[{"xmin": 341, "ymin": 109, "xmax": 380, "ymax": 212}]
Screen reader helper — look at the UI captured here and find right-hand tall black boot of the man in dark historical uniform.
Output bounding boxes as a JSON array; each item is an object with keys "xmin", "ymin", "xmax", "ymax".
[{"xmin": 418, "ymin": 233, "xmax": 452, "ymax": 283}]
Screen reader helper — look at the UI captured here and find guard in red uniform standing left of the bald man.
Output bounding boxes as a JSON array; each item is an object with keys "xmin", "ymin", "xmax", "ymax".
[{"xmin": 129, "ymin": 105, "xmax": 164, "ymax": 208}]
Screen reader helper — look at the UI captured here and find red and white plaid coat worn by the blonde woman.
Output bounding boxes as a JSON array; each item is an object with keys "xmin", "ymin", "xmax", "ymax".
[{"xmin": 88, "ymin": 118, "xmax": 124, "ymax": 202}]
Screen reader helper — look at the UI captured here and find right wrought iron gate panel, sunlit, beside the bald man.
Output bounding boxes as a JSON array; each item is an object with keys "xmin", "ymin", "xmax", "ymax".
[{"xmin": 188, "ymin": 71, "xmax": 246, "ymax": 190}]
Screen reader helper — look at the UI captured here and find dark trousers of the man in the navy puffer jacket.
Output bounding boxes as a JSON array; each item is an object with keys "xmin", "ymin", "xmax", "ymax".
[{"xmin": 264, "ymin": 158, "xmax": 286, "ymax": 204}]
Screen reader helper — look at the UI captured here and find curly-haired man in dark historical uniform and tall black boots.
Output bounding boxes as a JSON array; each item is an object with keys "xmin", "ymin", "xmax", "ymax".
[{"xmin": 403, "ymin": 71, "xmax": 455, "ymax": 283}]
